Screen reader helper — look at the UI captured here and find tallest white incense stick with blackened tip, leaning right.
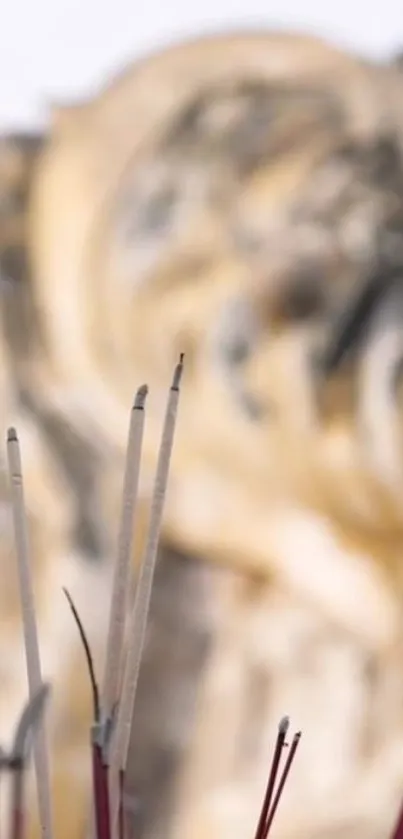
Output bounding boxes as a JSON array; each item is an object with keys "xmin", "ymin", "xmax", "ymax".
[{"xmin": 110, "ymin": 355, "xmax": 183, "ymax": 831}]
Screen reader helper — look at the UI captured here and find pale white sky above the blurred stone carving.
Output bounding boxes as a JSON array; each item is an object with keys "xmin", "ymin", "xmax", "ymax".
[{"xmin": 0, "ymin": 0, "xmax": 403, "ymax": 129}]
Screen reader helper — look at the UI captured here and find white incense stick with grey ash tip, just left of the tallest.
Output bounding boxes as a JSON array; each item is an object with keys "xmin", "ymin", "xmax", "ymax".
[{"xmin": 102, "ymin": 385, "xmax": 148, "ymax": 719}]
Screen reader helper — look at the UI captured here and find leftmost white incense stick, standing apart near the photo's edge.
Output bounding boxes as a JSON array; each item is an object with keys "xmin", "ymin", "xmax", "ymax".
[{"xmin": 7, "ymin": 428, "xmax": 53, "ymax": 839}]
